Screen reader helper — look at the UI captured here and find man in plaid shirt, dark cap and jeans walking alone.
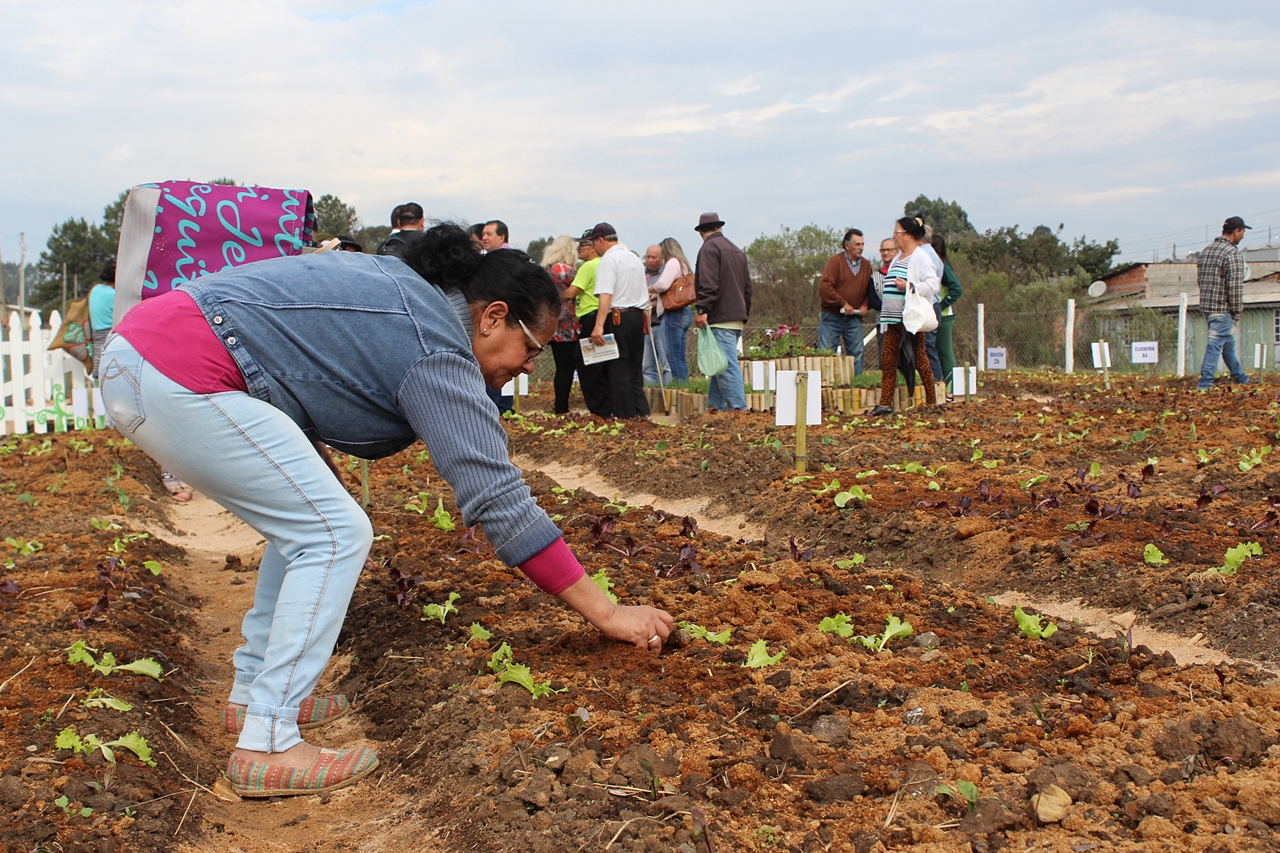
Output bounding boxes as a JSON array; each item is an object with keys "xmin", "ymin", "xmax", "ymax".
[{"xmin": 1196, "ymin": 216, "xmax": 1249, "ymax": 391}]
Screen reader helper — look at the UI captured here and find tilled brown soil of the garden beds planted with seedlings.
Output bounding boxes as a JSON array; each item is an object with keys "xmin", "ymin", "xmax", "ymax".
[{"xmin": 0, "ymin": 371, "xmax": 1280, "ymax": 853}]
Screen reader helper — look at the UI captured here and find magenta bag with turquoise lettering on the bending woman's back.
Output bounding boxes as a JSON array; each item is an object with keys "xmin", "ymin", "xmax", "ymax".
[{"xmin": 115, "ymin": 181, "xmax": 315, "ymax": 323}]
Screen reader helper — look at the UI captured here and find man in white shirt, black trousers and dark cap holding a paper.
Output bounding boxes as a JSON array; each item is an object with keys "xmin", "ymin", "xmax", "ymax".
[{"xmin": 582, "ymin": 222, "xmax": 649, "ymax": 418}]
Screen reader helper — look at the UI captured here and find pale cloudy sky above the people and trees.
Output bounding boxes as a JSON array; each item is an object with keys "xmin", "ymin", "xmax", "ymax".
[{"xmin": 0, "ymin": 0, "xmax": 1280, "ymax": 266}]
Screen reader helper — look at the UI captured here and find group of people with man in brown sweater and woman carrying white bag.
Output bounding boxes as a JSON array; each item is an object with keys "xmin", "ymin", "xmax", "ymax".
[{"xmin": 818, "ymin": 216, "xmax": 963, "ymax": 415}]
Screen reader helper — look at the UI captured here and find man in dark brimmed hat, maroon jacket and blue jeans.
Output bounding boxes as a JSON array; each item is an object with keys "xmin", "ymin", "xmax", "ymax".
[{"xmin": 694, "ymin": 213, "xmax": 751, "ymax": 411}]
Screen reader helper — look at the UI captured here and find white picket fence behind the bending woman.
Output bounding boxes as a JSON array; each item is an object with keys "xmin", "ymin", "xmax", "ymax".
[{"xmin": 0, "ymin": 311, "xmax": 106, "ymax": 435}]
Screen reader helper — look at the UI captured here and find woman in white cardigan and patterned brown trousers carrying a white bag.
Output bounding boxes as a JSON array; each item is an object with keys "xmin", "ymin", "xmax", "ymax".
[{"xmin": 872, "ymin": 216, "xmax": 942, "ymax": 415}]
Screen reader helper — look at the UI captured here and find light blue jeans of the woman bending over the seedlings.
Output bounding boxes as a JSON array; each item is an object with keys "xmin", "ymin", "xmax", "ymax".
[{"xmin": 101, "ymin": 336, "xmax": 374, "ymax": 752}]
